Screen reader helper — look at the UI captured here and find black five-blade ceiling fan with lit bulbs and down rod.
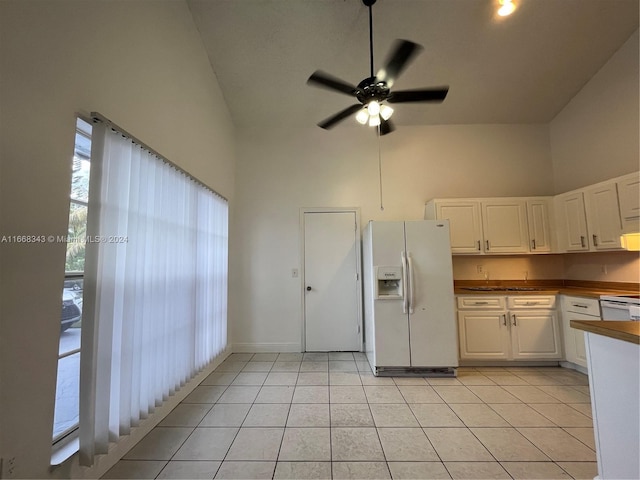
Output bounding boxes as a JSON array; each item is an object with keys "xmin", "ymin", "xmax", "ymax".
[{"xmin": 307, "ymin": 0, "xmax": 449, "ymax": 135}]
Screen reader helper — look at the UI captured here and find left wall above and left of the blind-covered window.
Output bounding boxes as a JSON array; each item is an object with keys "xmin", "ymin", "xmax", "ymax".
[{"xmin": 0, "ymin": 0, "xmax": 235, "ymax": 478}]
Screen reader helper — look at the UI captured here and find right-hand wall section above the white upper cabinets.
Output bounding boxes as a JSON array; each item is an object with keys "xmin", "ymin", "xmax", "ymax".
[{"xmin": 549, "ymin": 30, "xmax": 640, "ymax": 193}]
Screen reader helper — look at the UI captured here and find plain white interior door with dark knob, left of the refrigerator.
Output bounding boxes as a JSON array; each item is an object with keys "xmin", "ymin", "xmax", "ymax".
[{"xmin": 303, "ymin": 211, "xmax": 362, "ymax": 352}]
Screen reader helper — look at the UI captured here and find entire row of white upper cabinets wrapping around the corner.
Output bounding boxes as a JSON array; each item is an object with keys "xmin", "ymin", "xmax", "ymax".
[{"xmin": 424, "ymin": 172, "xmax": 640, "ymax": 255}]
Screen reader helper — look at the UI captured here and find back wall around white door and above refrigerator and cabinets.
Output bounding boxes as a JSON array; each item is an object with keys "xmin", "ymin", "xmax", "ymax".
[{"xmin": 230, "ymin": 122, "xmax": 552, "ymax": 349}]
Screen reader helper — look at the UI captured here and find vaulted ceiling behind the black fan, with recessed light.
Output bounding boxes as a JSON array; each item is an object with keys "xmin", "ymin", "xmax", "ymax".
[{"xmin": 187, "ymin": 0, "xmax": 639, "ymax": 128}]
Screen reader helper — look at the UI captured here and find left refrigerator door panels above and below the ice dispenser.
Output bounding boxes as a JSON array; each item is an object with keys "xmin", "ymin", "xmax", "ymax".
[{"xmin": 367, "ymin": 222, "xmax": 411, "ymax": 367}]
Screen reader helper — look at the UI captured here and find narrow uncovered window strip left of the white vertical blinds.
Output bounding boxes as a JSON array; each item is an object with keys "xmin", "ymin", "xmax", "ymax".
[{"xmin": 53, "ymin": 118, "xmax": 92, "ymax": 443}]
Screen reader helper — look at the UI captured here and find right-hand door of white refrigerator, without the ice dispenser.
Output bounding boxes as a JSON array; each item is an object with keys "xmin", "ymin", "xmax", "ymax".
[{"xmin": 405, "ymin": 220, "xmax": 458, "ymax": 367}]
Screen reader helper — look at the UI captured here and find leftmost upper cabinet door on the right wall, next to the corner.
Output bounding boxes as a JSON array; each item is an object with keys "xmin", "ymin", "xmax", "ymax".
[{"xmin": 556, "ymin": 192, "xmax": 589, "ymax": 252}]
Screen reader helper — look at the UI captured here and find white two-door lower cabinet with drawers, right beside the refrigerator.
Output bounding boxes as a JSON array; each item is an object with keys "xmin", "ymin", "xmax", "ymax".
[{"xmin": 457, "ymin": 295, "xmax": 562, "ymax": 360}]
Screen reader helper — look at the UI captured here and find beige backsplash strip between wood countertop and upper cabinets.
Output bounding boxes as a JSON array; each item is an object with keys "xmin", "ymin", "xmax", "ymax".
[{"xmin": 453, "ymin": 252, "xmax": 640, "ymax": 283}]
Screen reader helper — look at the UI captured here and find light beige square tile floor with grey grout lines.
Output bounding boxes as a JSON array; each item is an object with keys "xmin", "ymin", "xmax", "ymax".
[{"xmin": 103, "ymin": 352, "xmax": 597, "ymax": 479}]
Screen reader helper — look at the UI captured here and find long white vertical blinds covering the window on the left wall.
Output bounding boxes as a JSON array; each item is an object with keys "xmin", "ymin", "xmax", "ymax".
[{"xmin": 79, "ymin": 122, "xmax": 228, "ymax": 465}]
